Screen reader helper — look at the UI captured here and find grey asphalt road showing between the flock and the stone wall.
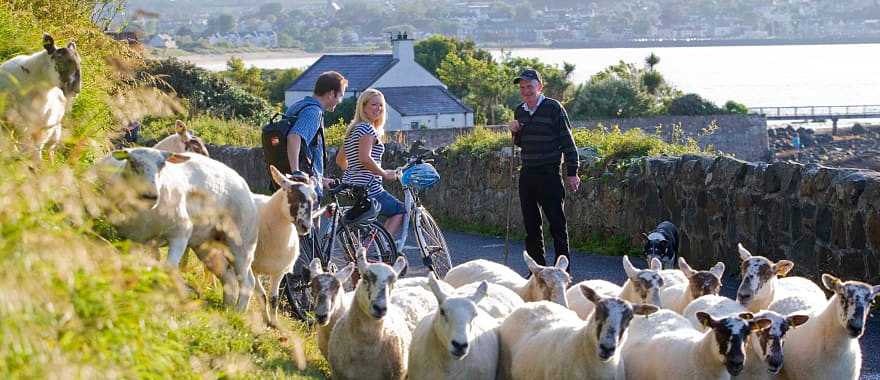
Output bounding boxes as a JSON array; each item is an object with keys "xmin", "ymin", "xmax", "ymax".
[{"xmin": 404, "ymin": 232, "xmax": 880, "ymax": 380}]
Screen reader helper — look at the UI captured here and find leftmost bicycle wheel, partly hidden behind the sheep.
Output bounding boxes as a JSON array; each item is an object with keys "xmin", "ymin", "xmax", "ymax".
[{"xmin": 279, "ymin": 235, "xmax": 320, "ymax": 324}]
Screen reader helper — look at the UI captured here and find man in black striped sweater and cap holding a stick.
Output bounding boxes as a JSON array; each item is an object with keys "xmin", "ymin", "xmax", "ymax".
[{"xmin": 508, "ymin": 69, "xmax": 581, "ymax": 272}]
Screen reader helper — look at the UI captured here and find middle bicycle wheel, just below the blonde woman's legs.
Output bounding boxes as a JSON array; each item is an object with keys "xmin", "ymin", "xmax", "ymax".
[{"xmin": 330, "ymin": 221, "xmax": 400, "ymax": 274}]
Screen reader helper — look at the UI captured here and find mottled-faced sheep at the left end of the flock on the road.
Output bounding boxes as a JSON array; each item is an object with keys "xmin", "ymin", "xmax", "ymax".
[{"xmin": 309, "ymin": 257, "xmax": 354, "ymax": 358}]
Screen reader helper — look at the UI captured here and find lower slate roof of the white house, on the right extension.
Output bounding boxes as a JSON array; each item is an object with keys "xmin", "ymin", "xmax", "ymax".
[{"xmin": 379, "ymin": 86, "xmax": 474, "ymax": 116}]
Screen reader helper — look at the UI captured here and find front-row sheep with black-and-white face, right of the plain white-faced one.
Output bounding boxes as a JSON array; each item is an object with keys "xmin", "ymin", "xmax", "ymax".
[{"xmin": 499, "ymin": 285, "xmax": 658, "ymax": 379}]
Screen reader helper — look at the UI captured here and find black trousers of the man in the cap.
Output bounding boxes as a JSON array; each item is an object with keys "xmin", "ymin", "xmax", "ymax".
[{"xmin": 519, "ymin": 168, "xmax": 571, "ymax": 272}]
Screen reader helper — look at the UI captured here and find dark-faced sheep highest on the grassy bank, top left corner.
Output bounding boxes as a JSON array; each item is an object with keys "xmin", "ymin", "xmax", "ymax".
[{"xmin": 0, "ymin": 33, "xmax": 82, "ymax": 160}]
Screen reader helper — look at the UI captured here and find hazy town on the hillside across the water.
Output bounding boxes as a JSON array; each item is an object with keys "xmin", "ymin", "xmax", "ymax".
[{"xmin": 109, "ymin": 0, "xmax": 880, "ymax": 52}]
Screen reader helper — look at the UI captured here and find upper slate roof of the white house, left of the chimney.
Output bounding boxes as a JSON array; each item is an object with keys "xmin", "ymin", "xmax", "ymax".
[{"xmin": 287, "ymin": 54, "xmax": 397, "ymax": 92}]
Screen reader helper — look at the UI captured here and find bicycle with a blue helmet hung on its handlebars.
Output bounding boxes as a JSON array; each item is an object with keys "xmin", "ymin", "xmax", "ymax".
[{"xmin": 397, "ymin": 151, "xmax": 452, "ymax": 278}]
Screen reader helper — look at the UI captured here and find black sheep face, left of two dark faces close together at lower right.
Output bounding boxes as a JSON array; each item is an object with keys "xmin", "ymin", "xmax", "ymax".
[{"xmin": 697, "ymin": 311, "xmax": 770, "ymax": 376}]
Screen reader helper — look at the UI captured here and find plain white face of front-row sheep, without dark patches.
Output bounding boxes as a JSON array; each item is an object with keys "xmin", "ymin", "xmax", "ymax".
[{"xmin": 428, "ymin": 272, "xmax": 489, "ymax": 360}]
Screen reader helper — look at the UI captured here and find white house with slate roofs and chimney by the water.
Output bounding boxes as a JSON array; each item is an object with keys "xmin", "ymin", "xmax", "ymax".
[{"xmin": 284, "ymin": 34, "xmax": 474, "ymax": 131}]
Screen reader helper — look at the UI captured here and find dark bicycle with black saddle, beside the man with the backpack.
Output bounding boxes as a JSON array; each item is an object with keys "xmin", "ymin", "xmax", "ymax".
[{"xmin": 281, "ymin": 180, "xmax": 400, "ymax": 324}]
